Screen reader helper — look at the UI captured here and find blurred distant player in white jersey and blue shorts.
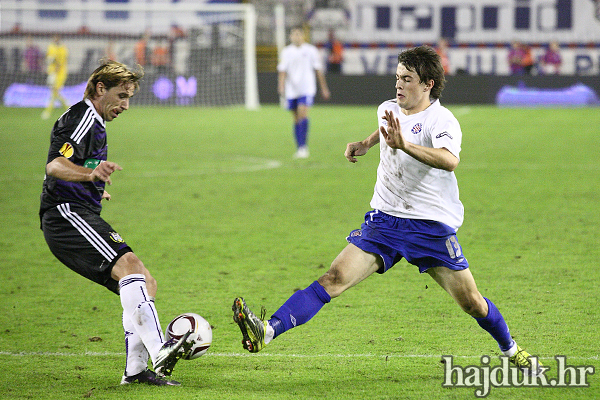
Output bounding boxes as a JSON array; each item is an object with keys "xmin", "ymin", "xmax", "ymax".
[{"xmin": 277, "ymin": 27, "xmax": 330, "ymax": 158}]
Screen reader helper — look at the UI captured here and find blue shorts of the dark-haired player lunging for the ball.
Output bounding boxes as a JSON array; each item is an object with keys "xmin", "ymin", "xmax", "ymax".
[{"xmin": 346, "ymin": 210, "xmax": 469, "ymax": 274}]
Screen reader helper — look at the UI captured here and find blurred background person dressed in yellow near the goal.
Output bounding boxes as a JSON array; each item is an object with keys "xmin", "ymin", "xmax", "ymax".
[{"xmin": 42, "ymin": 35, "xmax": 69, "ymax": 119}]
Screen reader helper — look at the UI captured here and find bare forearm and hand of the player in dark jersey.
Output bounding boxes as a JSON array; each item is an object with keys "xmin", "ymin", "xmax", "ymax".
[{"xmin": 46, "ymin": 157, "xmax": 123, "ymax": 185}]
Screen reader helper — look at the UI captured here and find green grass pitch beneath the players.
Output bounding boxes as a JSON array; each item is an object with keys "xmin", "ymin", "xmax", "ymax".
[{"xmin": 0, "ymin": 103, "xmax": 600, "ymax": 400}]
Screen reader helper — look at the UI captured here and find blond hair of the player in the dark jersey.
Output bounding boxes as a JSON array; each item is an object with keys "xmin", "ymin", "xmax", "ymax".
[{"xmin": 83, "ymin": 60, "xmax": 144, "ymax": 99}]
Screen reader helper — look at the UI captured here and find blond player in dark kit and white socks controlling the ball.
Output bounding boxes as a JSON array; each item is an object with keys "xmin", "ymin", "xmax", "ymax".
[{"xmin": 40, "ymin": 61, "xmax": 193, "ymax": 386}]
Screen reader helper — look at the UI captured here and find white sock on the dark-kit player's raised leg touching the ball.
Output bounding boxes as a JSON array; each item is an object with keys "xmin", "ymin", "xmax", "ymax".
[{"xmin": 119, "ymin": 274, "xmax": 164, "ymax": 362}]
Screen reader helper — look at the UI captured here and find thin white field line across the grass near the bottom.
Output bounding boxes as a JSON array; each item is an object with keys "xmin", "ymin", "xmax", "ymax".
[{"xmin": 0, "ymin": 351, "xmax": 600, "ymax": 360}]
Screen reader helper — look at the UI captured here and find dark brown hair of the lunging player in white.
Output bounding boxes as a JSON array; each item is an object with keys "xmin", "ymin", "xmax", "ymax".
[{"xmin": 398, "ymin": 46, "xmax": 446, "ymax": 99}]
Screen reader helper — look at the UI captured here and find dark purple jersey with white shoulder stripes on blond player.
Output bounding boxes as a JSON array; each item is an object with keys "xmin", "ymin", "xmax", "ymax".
[{"xmin": 40, "ymin": 99, "xmax": 107, "ymax": 216}]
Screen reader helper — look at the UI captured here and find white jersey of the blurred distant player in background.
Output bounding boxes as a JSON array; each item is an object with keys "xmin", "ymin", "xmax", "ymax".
[{"xmin": 277, "ymin": 43, "xmax": 323, "ymax": 99}]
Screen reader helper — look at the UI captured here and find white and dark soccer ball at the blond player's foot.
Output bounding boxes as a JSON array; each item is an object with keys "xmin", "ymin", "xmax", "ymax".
[{"xmin": 165, "ymin": 313, "xmax": 212, "ymax": 360}]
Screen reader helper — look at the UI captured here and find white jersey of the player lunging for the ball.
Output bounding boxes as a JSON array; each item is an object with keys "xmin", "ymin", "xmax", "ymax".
[{"xmin": 371, "ymin": 100, "xmax": 464, "ymax": 230}]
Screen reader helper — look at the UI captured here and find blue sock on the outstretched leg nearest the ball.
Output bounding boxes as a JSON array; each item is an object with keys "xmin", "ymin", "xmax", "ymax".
[{"xmin": 269, "ymin": 281, "xmax": 331, "ymax": 337}]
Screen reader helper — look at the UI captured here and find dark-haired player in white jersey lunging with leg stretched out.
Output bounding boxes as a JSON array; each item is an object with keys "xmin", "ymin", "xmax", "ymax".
[{"xmin": 233, "ymin": 46, "xmax": 540, "ymax": 373}]
